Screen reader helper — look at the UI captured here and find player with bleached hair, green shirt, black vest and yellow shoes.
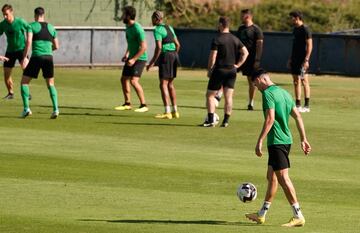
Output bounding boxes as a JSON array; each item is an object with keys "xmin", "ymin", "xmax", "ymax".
[{"xmin": 146, "ymin": 11, "xmax": 180, "ymax": 119}]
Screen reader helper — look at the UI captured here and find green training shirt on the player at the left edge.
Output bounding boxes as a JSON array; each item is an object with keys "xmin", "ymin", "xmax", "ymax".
[{"xmin": 0, "ymin": 17, "xmax": 29, "ymax": 52}]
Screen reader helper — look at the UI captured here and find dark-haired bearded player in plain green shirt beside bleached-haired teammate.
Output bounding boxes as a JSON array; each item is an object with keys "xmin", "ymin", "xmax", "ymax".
[{"xmin": 115, "ymin": 6, "xmax": 149, "ymax": 112}]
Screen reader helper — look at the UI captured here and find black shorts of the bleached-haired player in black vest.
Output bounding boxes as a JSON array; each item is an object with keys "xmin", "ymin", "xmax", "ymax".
[{"xmin": 158, "ymin": 51, "xmax": 178, "ymax": 79}]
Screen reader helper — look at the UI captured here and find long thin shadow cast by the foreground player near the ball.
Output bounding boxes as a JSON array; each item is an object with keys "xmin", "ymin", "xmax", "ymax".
[{"xmin": 78, "ymin": 219, "xmax": 259, "ymax": 226}]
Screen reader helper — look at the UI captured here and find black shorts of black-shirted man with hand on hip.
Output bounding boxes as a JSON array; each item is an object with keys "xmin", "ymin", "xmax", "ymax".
[{"xmin": 207, "ymin": 67, "xmax": 236, "ymax": 91}]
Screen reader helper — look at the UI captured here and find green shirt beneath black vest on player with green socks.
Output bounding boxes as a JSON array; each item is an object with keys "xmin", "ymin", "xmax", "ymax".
[{"xmin": 29, "ymin": 22, "xmax": 57, "ymax": 57}]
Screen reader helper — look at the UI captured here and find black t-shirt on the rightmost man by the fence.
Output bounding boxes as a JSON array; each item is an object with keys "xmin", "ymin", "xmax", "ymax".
[{"xmin": 291, "ymin": 25, "xmax": 312, "ymax": 60}]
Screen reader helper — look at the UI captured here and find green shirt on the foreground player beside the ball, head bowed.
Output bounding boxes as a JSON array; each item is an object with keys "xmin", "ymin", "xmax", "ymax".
[{"xmin": 262, "ymin": 85, "xmax": 295, "ymax": 146}]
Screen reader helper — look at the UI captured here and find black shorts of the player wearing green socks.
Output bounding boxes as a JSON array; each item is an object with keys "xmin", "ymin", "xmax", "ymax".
[{"xmin": 23, "ymin": 55, "xmax": 54, "ymax": 78}]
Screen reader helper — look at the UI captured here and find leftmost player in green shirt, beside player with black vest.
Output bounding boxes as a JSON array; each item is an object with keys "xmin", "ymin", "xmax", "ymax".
[{"xmin": 0, "ymin": 4, "xmax": 29, "ymax": 99}]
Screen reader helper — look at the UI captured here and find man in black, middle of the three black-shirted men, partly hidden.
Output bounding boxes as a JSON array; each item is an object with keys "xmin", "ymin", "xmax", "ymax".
[{"xmin": 236, "ymin": 9, "xmax": 264, "ymax": 110}]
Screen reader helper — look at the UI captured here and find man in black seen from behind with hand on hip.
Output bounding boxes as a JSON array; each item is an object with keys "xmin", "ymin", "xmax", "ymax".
[{"xmin": 203, "ymin": 16, "xmax": 249, "ymax": 127}]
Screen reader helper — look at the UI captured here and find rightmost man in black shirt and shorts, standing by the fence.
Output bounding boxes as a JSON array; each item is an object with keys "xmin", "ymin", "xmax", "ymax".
[{"xmin": 288, "ymin": 11, "xmax": 313, "ymax": 112}]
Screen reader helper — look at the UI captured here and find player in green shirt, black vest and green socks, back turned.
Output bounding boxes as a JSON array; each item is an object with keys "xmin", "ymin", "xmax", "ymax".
[{"xmin": 21, "ymin": 7, "xmax": 59, "ymax": 119}]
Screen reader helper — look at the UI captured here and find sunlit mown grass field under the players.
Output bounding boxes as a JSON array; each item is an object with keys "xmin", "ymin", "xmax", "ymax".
[{"xmin": 0, "ymin": 69, "xmax": 360, "ymax": 233}]
